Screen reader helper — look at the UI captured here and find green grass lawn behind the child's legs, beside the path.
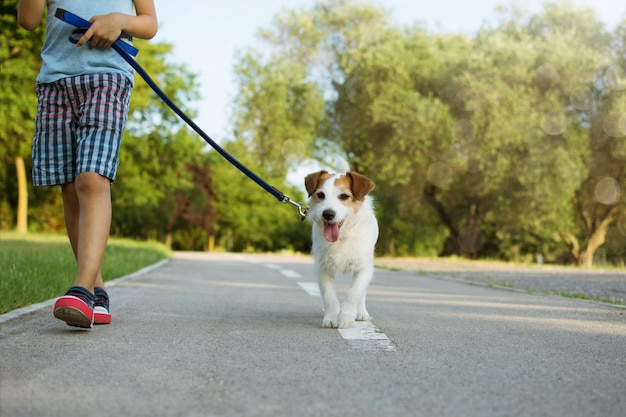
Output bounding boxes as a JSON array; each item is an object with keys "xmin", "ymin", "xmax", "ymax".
[{"xmin": 0, "ymin": 232, "xmax": 170, "ymax": 314}]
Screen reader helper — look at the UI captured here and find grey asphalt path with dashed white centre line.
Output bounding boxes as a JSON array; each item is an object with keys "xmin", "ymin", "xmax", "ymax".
[{"xmin": 0, "ymin": 253, "xmax": 626, "ymax": 417}]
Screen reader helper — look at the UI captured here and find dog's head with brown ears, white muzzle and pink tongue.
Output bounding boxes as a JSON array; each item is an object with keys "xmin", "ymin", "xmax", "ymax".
[{"xmin": 304, "ymin": 171, "xmax": 374, "ymax": 242}]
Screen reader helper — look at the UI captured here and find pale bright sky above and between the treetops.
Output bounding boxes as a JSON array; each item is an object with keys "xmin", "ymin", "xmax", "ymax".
[{"xmin": 149, "ymin": 0, "xmax": 626, "ymax": 142}]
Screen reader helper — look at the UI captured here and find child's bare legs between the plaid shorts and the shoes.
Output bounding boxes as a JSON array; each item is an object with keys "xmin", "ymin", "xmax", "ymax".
[{"xmin": 62, "ymin": 172, "xmax": 111, "ymax": 293}]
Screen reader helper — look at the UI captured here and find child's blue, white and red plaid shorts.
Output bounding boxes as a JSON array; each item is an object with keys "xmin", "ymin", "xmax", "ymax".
[{"xmin": 32, "ymin": 74, "xmax": 132, "ymax": 186}]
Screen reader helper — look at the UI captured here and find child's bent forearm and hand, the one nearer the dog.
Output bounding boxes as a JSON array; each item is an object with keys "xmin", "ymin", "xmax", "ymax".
[{"xmin": 76, "ymin": 0, "xmax": 158, "ymax": 48}]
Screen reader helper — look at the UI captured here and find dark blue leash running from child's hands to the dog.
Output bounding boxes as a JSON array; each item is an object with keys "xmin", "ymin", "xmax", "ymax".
[{"xmin": 54, "ymin": 9, "xmax": 307, "ymax": 220}]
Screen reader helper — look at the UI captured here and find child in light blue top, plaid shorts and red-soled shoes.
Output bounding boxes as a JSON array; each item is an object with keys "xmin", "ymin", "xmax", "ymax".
[{"xmin": 17, "ymin": 0, "xmax": 157, "ymax": 328}]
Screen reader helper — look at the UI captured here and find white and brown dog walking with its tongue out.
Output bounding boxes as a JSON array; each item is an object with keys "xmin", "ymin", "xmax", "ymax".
[{"xmin": 304, "ymin": 160, "xmax": 378, "ymax": 329}]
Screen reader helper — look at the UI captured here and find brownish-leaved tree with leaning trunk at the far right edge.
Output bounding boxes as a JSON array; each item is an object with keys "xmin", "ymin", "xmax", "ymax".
[{"xmin": 566, "ymin": 21, "xmax": 626, "ymax": 267}]
